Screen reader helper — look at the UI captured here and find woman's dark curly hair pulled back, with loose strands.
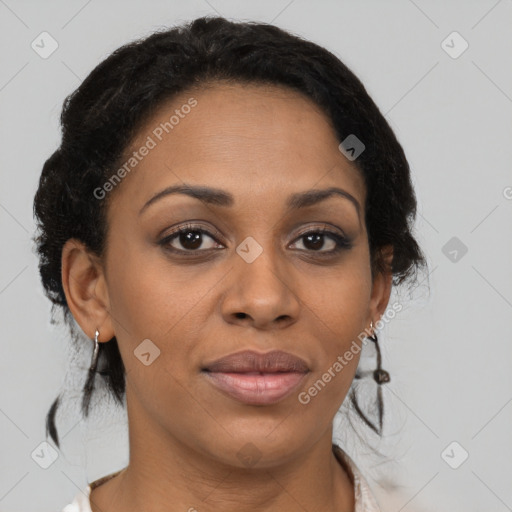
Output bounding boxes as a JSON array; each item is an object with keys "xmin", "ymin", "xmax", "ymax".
[{"xmin": 34, "ymin": 17, "xmax": 426, "ymax": 446}]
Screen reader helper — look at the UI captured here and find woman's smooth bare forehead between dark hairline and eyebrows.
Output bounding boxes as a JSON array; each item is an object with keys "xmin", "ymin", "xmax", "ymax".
[{"xmin": 108, "ymin": 83, "xmax": 365, "ymax": 216}]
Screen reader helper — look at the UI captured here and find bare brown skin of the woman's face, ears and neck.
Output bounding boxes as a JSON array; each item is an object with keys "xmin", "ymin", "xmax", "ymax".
[{"xmin": 62, "ymin": 83, "xmax": 392, "ymax": 512}]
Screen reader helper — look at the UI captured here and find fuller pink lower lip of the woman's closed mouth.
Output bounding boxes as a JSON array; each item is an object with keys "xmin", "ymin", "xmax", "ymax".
[{"xmin": 203, "ymin": 371, "xmax": 307, "ymax": 405}]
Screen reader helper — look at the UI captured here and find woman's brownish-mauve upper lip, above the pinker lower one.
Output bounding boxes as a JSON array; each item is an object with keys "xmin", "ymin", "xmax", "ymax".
[{"xmin": 203, "ymin": 350, "xmax": 309, "ymax": 373}]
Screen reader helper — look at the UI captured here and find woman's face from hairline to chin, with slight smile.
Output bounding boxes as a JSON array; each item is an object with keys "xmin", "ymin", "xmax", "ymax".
[{"xmin": 66, "ymin": 84, "xmax": 389, "ymax": 467}]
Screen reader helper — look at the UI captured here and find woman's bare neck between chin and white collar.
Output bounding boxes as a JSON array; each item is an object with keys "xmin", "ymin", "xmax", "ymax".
[{"xmin": 91, "ymin": 386, "xmax": 354, "ymax": 512}]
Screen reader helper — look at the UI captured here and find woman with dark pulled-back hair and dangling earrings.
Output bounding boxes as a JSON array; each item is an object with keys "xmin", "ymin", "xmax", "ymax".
[{"xmin": 34, "ymin": 18, "xmax": 425, "ymax": 512}]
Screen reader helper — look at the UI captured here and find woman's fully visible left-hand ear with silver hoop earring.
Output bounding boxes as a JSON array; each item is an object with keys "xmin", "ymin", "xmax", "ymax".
[{"xmin": 61, "ymin": 239, "xmax": 115, "ymax": 341}]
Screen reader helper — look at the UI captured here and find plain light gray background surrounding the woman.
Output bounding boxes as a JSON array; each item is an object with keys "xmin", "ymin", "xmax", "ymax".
[{"xmin": 0, "ymin": 0, "xmax": 512, "ymax": 512}]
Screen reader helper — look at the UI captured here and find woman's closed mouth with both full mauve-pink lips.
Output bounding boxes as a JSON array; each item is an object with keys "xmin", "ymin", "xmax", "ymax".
[{"xmin": 202, "ymin": 351, "xmax": 310, "ymax": 405}]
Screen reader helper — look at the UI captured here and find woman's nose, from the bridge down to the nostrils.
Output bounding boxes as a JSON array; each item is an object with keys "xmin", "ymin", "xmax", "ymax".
[{"xmin": 221, "ymin": 245, "xmax": 300, "ymax": 330}]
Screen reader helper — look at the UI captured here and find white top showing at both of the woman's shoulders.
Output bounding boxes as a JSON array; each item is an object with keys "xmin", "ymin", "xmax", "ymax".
[{"xmin": 62, "ymin": 444, "xmax": 381, "ymax": 512}]
